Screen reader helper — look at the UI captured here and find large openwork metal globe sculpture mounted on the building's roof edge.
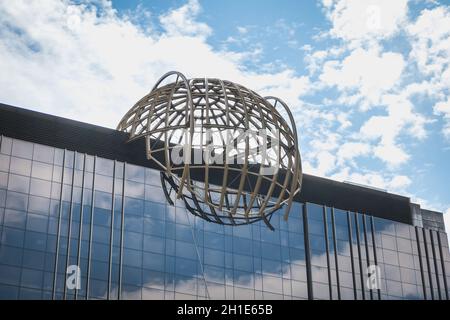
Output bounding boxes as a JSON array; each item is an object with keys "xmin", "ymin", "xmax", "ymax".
[{"xmin": 117, "ymin": 71, "xmax": 302, "ymax": 230}]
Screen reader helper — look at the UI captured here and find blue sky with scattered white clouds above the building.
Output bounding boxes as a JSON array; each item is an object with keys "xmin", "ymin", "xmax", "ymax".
[{"xmin": 0, "ymin": 0, "xmax": 450, "ymax": 230}]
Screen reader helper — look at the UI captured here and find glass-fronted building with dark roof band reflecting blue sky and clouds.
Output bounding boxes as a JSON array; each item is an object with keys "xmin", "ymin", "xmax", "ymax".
[{"xmin": 0, "ymin": 104, "xmax": 450, "ymax": 300}]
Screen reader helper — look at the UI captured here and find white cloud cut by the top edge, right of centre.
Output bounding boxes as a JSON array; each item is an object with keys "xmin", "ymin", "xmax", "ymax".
[{"xmin": 323, "ymin": 0, "xmax": 408, "ymax": 47}]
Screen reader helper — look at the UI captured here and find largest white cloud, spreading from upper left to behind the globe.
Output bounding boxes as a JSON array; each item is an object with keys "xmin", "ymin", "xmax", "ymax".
[{"xmin": 0, "ymin": 0, "xmax": 309, "ymax": 127}]
